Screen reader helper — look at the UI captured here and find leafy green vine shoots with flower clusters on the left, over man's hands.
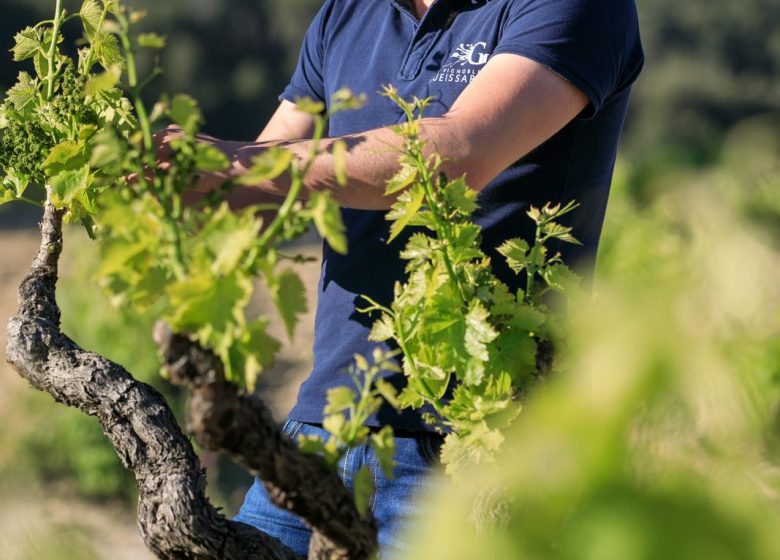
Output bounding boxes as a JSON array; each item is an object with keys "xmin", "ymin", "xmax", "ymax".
[{"xmin": 0, "ymin": 0, "xmax": 354, "ymax": 389}]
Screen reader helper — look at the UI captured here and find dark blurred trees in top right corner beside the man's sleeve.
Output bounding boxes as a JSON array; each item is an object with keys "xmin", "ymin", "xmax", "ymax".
[{"xmin": 623, "ymin": 0, "xmax": 780, "ymax": 165}]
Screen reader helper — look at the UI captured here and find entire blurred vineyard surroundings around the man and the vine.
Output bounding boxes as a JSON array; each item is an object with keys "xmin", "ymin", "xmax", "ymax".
[{"xmin": 0, "ymin": 0, "xmax": 780, "ymax": 560}]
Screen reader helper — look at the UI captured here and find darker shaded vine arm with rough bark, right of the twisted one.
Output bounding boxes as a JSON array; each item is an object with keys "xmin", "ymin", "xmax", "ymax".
[{"xmin": 154, "ymin": 323, "xmax": 376, "ymax": 559}]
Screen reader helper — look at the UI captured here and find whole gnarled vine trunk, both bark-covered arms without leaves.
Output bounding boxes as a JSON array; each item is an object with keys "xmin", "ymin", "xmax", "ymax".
[{"xmin": 7, "ymin": 202, "xmax": 376, "ymax": 560}]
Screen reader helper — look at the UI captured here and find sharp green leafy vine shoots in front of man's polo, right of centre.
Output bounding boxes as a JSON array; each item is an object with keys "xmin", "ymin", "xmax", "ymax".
[{"xmin": 356, "ymin": 87, "xmax": 579, "ymax": 475}]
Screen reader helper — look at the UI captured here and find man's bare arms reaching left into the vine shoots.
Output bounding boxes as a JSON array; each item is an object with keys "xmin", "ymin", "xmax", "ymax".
[{"xmin": 168, "ymin": 54, "xmax": 588, "ymax": 210}]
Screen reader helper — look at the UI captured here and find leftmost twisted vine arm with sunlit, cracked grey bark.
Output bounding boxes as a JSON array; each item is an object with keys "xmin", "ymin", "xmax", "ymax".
[{"xmin": 7, "ymin": 204, "xmax": 298, "ymax": 560}]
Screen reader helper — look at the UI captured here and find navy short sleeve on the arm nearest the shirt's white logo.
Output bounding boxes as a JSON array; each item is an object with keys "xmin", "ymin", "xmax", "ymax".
[{"xmin": 493, "ymin": 0, "xmax": 644, "ymax": 116}]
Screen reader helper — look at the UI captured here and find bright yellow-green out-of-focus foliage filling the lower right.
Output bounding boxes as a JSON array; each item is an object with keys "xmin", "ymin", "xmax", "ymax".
[{"xmin": 410, "ymin": 115, "xmax": 780, "ymax": 560}]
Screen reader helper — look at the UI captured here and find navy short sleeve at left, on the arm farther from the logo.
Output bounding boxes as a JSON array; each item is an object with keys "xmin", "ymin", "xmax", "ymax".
[{"xmin": 279, "ymin": 0, "xmax": 333, "ymax": 102}]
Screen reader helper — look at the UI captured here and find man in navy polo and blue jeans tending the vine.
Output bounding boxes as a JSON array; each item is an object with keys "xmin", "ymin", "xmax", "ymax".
[{"xmin": 158, "ymin": 0, "xmax": 643, "ymax": 556}]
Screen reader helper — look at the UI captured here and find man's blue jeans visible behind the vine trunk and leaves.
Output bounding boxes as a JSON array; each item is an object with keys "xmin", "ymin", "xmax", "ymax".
[{"xmin": 235, "ymin": 420, "xmax": 443, "ymax": 560}]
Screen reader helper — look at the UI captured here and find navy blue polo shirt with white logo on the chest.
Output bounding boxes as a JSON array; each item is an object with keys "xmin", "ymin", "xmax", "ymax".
[{"xmin": 280, "ymin": 0, "xmax": 643, "ymax": 430}]
